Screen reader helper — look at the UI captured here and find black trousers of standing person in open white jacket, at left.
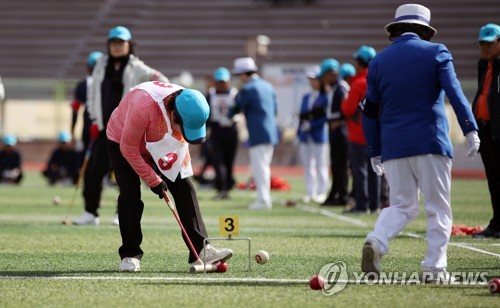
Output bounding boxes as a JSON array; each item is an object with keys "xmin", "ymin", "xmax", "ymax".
[{"xmin": 83, "ymin": 130, "xmax": 111, "ymax": 216}]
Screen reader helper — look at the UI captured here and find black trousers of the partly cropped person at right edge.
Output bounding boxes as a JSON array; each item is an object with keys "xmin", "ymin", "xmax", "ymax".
[{"xmin": 478, "ymin": 122, "xmax": 500, "ymax": 232}]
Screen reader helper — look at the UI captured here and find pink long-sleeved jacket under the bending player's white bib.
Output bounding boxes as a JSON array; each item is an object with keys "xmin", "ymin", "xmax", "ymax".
[{"xmin": 106, "ymin": 89, "xmax": 185, "ymax": 187}]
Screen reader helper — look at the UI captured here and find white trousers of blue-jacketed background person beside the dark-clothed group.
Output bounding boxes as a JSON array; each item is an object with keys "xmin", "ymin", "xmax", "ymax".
[{"xmin": 300, "ymin": 140, "xmax": 328, "ymax": 197}]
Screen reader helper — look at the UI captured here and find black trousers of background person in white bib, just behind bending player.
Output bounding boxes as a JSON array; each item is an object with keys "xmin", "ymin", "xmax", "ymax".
[{"xmin": 210, "ymin": 126, "xmax": 238, "ymax": 191}]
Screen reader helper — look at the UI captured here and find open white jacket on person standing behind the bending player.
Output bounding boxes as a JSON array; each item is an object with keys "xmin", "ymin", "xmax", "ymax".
[{"xmin": 87, "ymin": 55, "xmax": 169, "ymax": 130}]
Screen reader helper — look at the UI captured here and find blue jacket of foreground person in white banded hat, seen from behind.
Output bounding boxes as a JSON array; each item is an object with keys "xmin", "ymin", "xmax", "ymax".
[{"xmin": 363, "ymin": 34, "xmax": 477, "ymax": 161}]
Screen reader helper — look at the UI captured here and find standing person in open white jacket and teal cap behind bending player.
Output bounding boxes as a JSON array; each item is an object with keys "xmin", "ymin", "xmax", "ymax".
[{"xmin": 73, "ymin": 26, "xmax": 168, "ymax": 225}]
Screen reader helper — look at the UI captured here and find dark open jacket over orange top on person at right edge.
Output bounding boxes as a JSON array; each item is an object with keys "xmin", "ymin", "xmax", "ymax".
[{"xmin": 472, "ymin": 57, "xmax": 500, "ymax": 141}]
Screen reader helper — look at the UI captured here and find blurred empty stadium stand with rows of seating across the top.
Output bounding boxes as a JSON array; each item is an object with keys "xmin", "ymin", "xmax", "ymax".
[{"xmin": 0, "ymin": 0, "xmax": 500, "ymax": 79}]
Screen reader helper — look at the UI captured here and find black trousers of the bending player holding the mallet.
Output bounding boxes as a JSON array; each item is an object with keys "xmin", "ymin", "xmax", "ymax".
[{"xmin": 107, "ymin": 140, "xmax": 208, "ymax": 263}]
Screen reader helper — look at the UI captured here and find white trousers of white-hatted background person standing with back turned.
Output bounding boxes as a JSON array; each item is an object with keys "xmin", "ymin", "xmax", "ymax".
[{"xmin": 249, "ymin": 144, "xmax": 274, "ymax": 205}]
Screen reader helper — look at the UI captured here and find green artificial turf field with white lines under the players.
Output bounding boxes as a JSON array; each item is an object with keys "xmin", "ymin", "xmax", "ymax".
[{"xmin": 0, "ymin": 172, "xmax": 500, "ymax": 307}]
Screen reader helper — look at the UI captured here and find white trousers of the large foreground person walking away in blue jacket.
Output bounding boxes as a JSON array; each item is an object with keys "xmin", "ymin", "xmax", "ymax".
[{"xmin": 367, "ymin": 155, "xmax": 452, "ymax": 272}]
